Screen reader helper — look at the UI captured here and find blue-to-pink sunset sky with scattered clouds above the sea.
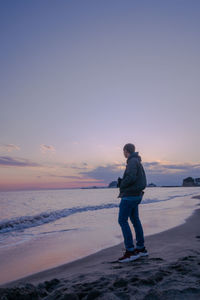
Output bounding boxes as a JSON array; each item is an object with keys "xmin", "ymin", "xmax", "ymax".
[{"xmin": 0, "ymin": 0, "xmax": 200, "ymax": 191}]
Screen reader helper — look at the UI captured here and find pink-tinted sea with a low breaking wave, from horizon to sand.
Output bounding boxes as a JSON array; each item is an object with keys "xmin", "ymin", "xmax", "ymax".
[{"xmin": 0, "ymin": 187, "xmax": 200, "ymax": 283}]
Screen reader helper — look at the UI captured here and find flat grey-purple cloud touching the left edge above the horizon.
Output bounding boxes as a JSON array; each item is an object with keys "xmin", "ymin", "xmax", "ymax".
[{"xmin": 0, "ymin": 156, "xmax": 40, "ymax": 167}]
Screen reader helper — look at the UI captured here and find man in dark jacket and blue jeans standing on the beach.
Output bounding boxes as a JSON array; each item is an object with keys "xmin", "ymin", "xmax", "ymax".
[{"xmin": 118, "ymin": 144, "xmax": 148, "ymax": 262}]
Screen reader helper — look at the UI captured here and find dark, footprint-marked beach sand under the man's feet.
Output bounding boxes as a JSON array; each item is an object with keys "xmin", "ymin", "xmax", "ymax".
[{"xmin": 0, "ymin": 196, "xmax": 200, "ymax": 300}]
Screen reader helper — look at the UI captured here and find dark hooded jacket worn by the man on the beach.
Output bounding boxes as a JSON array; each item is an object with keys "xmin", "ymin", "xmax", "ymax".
[{"xmin": 119, "ymin": 152, "xmax": 147, "ymax": 198}]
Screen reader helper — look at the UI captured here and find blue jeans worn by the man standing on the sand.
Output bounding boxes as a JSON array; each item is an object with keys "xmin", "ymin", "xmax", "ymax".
[{"xmin": 118, "ymin": 196, "xmax": 144, "ymax": 251}]
